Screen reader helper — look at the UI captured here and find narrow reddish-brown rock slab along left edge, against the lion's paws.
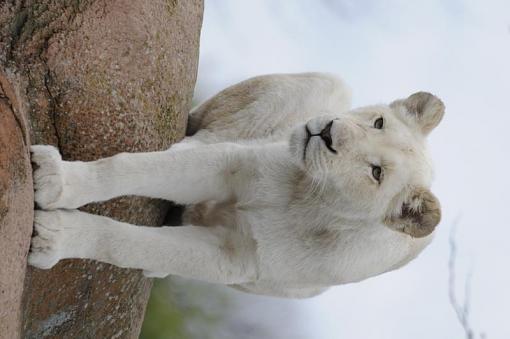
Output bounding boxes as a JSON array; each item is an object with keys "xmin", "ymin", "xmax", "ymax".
[{"xmin": 0, "ymin": 72, "xmax": 34, "ymax": 338}]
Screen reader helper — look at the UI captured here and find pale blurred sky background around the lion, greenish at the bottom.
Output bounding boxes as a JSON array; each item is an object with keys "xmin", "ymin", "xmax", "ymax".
[{"xmin": 141, "ymin": 0, "xmax": 510, "ymax": 339}]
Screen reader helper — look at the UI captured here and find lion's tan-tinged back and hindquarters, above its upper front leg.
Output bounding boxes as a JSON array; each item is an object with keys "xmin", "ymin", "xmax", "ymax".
[{"xmin": 187, "ymin": 73, "xmax": 351, "ymax": 142}]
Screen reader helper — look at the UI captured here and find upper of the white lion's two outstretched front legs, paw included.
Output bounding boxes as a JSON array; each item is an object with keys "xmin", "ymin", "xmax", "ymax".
[{"xmin": 32, "ymin": 144, "xmax": 243, "ymax": 209}]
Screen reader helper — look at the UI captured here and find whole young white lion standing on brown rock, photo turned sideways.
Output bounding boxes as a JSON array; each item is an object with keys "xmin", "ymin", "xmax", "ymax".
[{"xmin": 28, "ymin": 73, "xmax": 444, "ymax": 298}]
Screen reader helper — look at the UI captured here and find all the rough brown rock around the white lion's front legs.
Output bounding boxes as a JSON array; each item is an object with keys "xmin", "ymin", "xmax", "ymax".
[{"xmin": 0, "ymin": 0, "xmax": 203, "ymax": 338}]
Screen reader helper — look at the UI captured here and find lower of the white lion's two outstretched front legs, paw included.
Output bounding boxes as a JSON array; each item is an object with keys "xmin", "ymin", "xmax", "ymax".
[{"xmin": 28, "ymin": 210, "xmax": 256, "ymax": 284}]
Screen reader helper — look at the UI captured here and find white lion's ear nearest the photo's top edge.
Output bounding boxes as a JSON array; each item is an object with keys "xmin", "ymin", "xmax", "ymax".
[{"xmin": 390, "ymin": 92, "xmax": 444, "ymax": 135}]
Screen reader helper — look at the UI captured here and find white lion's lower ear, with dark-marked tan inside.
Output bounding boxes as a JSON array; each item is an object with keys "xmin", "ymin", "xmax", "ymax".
[{"xmin": 384, "ymin": 189, "xmax": 441, "ymax": 238}]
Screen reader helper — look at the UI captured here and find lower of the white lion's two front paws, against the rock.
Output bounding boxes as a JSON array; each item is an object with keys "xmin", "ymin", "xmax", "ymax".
[{"xmin": 28, "ymin": 211, "xmax": 65, "ymax": 269}]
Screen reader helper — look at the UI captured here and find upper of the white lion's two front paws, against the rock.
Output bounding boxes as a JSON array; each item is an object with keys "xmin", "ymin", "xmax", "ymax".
[{"xmin": 30, "ymin": 145, "xmax": 64, "ymax": 210}]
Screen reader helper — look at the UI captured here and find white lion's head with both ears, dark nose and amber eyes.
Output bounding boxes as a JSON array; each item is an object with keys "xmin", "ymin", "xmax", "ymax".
[{"xmin": 290, "ymin": 92, "xmax": 444, "ymax": 237}]
